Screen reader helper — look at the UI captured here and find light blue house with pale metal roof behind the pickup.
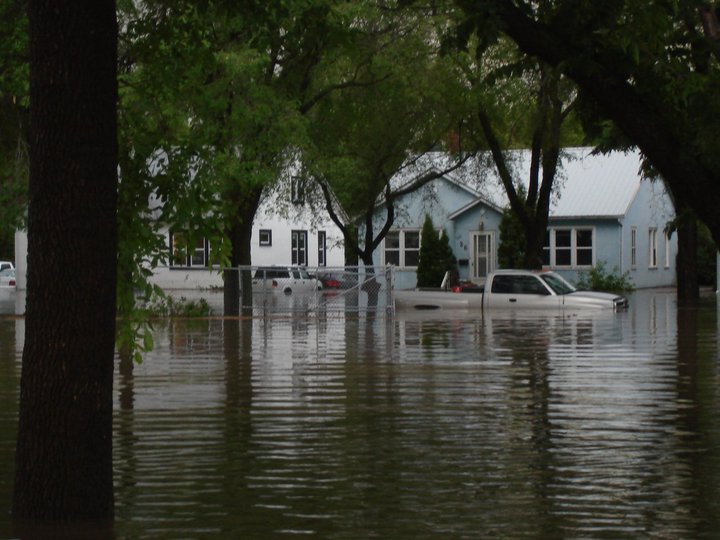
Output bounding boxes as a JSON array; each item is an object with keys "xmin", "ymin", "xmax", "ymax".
[{"xmin": 368, "ymin": 148, "xmax": 677, "ymax": 288}]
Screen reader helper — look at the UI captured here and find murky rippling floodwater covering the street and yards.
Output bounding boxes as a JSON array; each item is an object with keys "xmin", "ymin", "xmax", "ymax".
[{"xmin": 0, "ymin": 291, "xmax": 720, "ymax": 539}]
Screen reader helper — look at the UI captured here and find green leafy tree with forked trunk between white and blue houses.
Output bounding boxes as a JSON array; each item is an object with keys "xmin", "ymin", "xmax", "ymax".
[{"xmin": 303, "ymin": 3, "xmax": 467, "ymax": 265}]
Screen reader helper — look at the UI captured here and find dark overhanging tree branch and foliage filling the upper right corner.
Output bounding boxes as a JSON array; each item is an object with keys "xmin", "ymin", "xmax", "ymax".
[{"xmin": 455, "ymin": 0, "xmax": 720, "ymax": 249}]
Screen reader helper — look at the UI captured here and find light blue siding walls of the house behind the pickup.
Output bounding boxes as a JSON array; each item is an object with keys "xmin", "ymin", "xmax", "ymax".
[{"xmin": 374, "ymin": 154, "xmax": 677, "ymax": 294}]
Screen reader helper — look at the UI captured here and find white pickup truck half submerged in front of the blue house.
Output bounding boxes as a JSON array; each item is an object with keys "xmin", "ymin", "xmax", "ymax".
[{"xmin": 394, "ymin": 270, "xmax": 628, "ymax": 311}]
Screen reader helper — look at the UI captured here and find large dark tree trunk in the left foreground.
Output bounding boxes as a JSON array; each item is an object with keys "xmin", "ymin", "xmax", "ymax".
[{"xmin": 12, "ymin": 0, "xmax": 117, "ymax": 521}]
